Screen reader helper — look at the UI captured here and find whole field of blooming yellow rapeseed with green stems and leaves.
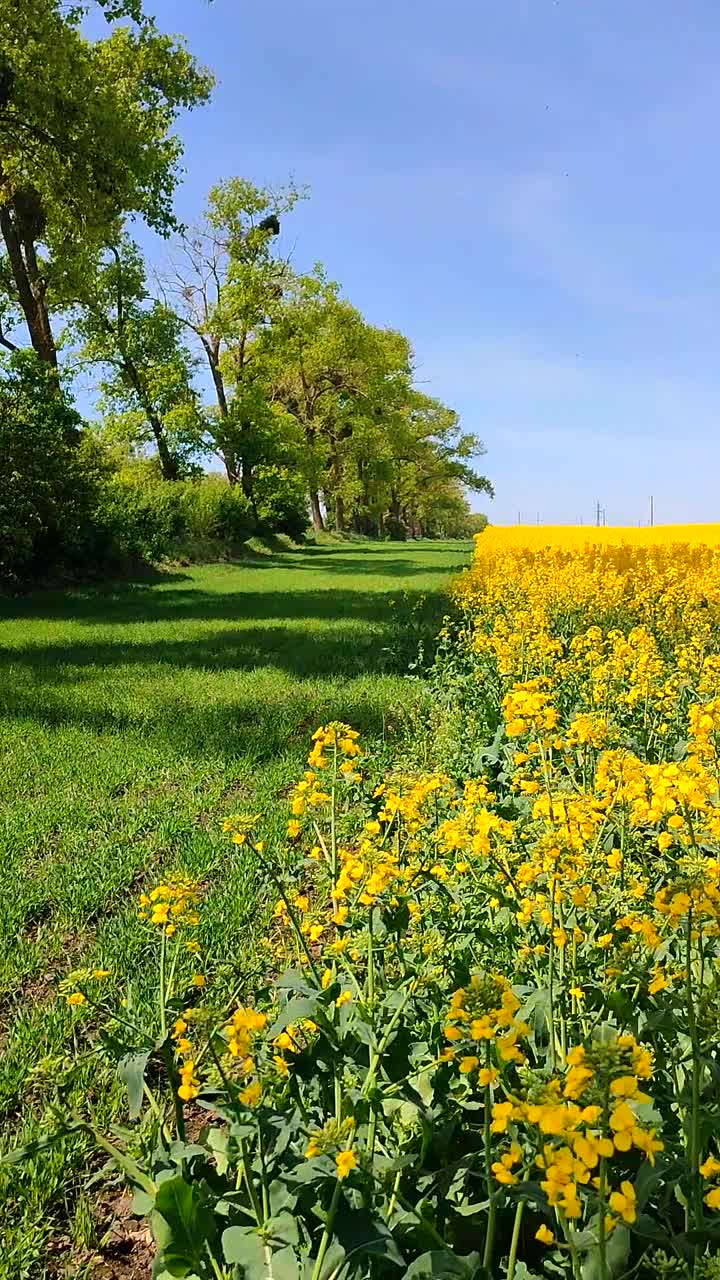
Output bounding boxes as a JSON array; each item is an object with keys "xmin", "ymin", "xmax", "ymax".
[{"xmin": 32, "ymin": 526, "xmax": 720, "ymax": 1280}]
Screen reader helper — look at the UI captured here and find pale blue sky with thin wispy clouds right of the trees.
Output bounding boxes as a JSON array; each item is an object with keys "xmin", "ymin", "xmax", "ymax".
[{"xmin": 112, "ymin": 0, "xmax": 720, "ymax": 524}]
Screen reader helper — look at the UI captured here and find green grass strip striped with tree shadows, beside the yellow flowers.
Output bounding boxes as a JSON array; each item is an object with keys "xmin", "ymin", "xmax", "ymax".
[{"xmin": 0, "ymin": 543, "xmax": 470, "ymax": 1277}]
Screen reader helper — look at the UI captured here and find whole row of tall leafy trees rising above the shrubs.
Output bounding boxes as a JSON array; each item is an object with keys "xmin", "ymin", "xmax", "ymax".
[{"xmin": 0, "ymin": 0, "xmax": 492, "ymax": 550}]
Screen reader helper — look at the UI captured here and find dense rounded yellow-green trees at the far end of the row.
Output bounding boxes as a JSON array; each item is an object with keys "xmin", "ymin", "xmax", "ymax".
[{"xmin": 260, "ymin": 269, "xmax": 492, "ymax": 538}]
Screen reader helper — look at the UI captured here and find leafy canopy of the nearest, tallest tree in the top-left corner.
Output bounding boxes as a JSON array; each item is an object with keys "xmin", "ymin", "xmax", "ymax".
[{"xmin": 0, "ymin": 0, "xmax": 213, "ymax": 365}]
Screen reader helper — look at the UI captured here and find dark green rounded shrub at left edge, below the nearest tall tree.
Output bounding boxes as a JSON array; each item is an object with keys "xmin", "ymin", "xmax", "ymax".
[{"xmin": 0, "ymin": 352, "xmax": 101, "ymax": 581}]
